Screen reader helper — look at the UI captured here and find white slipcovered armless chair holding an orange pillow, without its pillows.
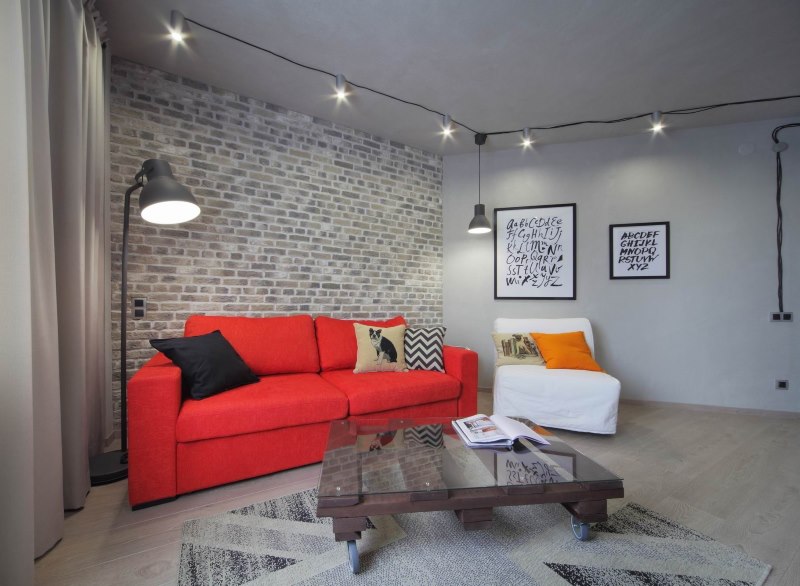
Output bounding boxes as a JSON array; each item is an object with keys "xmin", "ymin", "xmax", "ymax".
[{"xmin": 494, "ymin": 317, "xmax": 620, "ymax": 434}]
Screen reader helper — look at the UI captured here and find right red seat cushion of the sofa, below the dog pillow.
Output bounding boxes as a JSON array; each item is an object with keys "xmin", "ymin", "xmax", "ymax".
[{"xmin": 322, "ymin": 370, "xmax": 461, "ymax": 415}]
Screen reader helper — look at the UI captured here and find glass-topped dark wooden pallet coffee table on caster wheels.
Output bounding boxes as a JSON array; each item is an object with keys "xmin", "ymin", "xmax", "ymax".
[{"xmin": 317, "ymin": 417, "xmax": 624, "ymax": 573}]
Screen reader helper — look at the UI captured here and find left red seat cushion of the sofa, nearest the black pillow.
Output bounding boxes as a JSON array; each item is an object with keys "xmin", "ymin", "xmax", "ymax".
[{"xmin": 175, "ymin": 374, "xmax": 347, "ymax": 442}]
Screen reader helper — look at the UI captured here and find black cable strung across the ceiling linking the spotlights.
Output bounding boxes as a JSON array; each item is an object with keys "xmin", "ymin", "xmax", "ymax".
[{"xmin": 178, "ymin": 10, "xmax": 800, "ymax": 136}]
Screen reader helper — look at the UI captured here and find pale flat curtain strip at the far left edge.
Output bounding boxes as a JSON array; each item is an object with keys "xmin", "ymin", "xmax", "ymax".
[{"xmin": 0, "ymin": 2, "xmax": 34, "ymax": 584}]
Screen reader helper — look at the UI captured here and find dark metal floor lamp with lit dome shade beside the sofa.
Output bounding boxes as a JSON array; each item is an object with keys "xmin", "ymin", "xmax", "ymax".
[{"xmin": 89, "ymin": 159, "xmax": 200, "ymax": 486}]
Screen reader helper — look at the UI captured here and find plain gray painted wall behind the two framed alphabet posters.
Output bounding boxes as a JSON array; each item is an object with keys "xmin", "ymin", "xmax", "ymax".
[{"xmin": 443, "ymin": 120, "xmax": 800, "ymax": 411}]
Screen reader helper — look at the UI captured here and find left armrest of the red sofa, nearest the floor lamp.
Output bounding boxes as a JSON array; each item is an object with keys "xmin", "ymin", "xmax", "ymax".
[{"xmin": 128, "ymin": 354, "xmax": 181, "ymax": 507}]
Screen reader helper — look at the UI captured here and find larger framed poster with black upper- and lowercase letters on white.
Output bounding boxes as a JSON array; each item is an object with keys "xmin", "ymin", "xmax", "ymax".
[{"xmin": 494, "ymin": 203, "xmax": 576, "ymax": 299}]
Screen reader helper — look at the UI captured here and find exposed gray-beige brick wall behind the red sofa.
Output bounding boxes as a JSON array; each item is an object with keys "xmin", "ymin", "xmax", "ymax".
[{"xmin": 111, "ymin": 59, "xmax": 442, "ymax": 434}]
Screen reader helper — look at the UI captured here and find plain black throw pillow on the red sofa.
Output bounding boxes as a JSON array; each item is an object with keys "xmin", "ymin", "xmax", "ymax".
[{"xmin": 150, "ymin": 330, "xmax": 258, "ymax": 399}]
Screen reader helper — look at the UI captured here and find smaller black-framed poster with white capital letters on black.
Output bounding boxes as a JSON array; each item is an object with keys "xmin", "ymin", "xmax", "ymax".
[{"xmin": 609, "ymin": 222, "xmax": 669, "ymax": 279}]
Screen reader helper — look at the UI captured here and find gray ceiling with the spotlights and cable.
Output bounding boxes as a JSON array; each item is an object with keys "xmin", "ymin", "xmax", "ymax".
[{"xmin": 97, "ymin": 0, "xmax": 800, "ymax": 154}]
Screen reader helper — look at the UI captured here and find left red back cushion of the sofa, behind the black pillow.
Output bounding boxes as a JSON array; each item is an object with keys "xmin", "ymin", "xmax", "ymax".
[{"xmin": 184, "ymin": 315, "xmax": 319, "ymax": 376}]
